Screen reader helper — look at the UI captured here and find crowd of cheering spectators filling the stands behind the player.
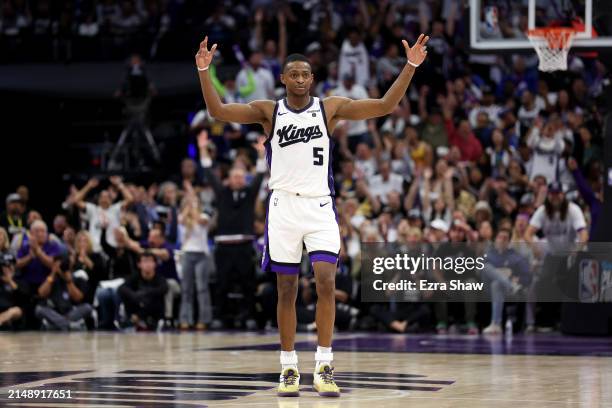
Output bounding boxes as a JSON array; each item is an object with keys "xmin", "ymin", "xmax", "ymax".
[{"xmin": 0, "ymin": 0, "xmax": 608, "ymax": 334}]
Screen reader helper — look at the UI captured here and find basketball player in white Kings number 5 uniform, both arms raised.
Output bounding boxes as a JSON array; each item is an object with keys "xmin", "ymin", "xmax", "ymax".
[{"xmin": 195, "ymin": 34, "xmax": 429, "ymax": 397}]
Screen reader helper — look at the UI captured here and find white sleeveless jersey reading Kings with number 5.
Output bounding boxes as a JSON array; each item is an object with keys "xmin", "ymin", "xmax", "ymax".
[{"xmin": 265, "ymin": 97, "xmax": 334, "ymax": 197}]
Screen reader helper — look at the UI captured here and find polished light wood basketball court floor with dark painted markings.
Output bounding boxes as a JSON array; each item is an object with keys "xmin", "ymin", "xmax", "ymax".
[{"xmin": 0, "ymin": 332, "xmax": 612, "ymax": 408}]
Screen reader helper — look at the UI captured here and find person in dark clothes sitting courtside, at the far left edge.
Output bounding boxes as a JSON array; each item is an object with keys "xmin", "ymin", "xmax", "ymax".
[{"xmin": 0, "ymin": 253, "xmax": 28, "ymax": 328}]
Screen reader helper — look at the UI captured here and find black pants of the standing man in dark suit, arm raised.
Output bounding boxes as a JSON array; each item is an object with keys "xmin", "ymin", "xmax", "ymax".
[{"xmin": 215, "ymin": 242, "xmax": 256, "ymax": 320}]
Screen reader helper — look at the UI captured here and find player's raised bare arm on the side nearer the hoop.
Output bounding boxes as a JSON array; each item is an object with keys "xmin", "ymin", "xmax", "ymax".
[{"xmin": 325, "ymin": 34, "xmax": 429, "ymax": 122}]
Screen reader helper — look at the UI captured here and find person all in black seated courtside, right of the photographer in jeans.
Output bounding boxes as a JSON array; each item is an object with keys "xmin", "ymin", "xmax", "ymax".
[{"xmin": 118, "ymin": 251, "xmax": 168, "ymax": 330}]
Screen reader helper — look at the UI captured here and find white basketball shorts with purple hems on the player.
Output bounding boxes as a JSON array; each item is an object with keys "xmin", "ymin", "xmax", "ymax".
[{"xmin": 261, "ymin": 190, "xmax": 340, "ymax": 274}]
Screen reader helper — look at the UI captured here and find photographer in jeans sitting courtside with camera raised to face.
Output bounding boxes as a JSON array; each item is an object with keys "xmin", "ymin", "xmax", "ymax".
[{"xmin": 35, "ymin": 255, "xmax": 93, "ymax": 331}]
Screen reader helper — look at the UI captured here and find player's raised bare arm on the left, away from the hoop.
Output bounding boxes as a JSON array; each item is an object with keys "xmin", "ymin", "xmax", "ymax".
[{"xmin": 195, "ymin": 37, "xmax": 274, "ymax": 126}]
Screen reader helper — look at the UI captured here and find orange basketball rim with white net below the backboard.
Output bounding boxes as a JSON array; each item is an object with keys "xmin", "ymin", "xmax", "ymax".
[{"xmin": 527, "ymin": 27, "xmax": 576, "ymax": 72}]
